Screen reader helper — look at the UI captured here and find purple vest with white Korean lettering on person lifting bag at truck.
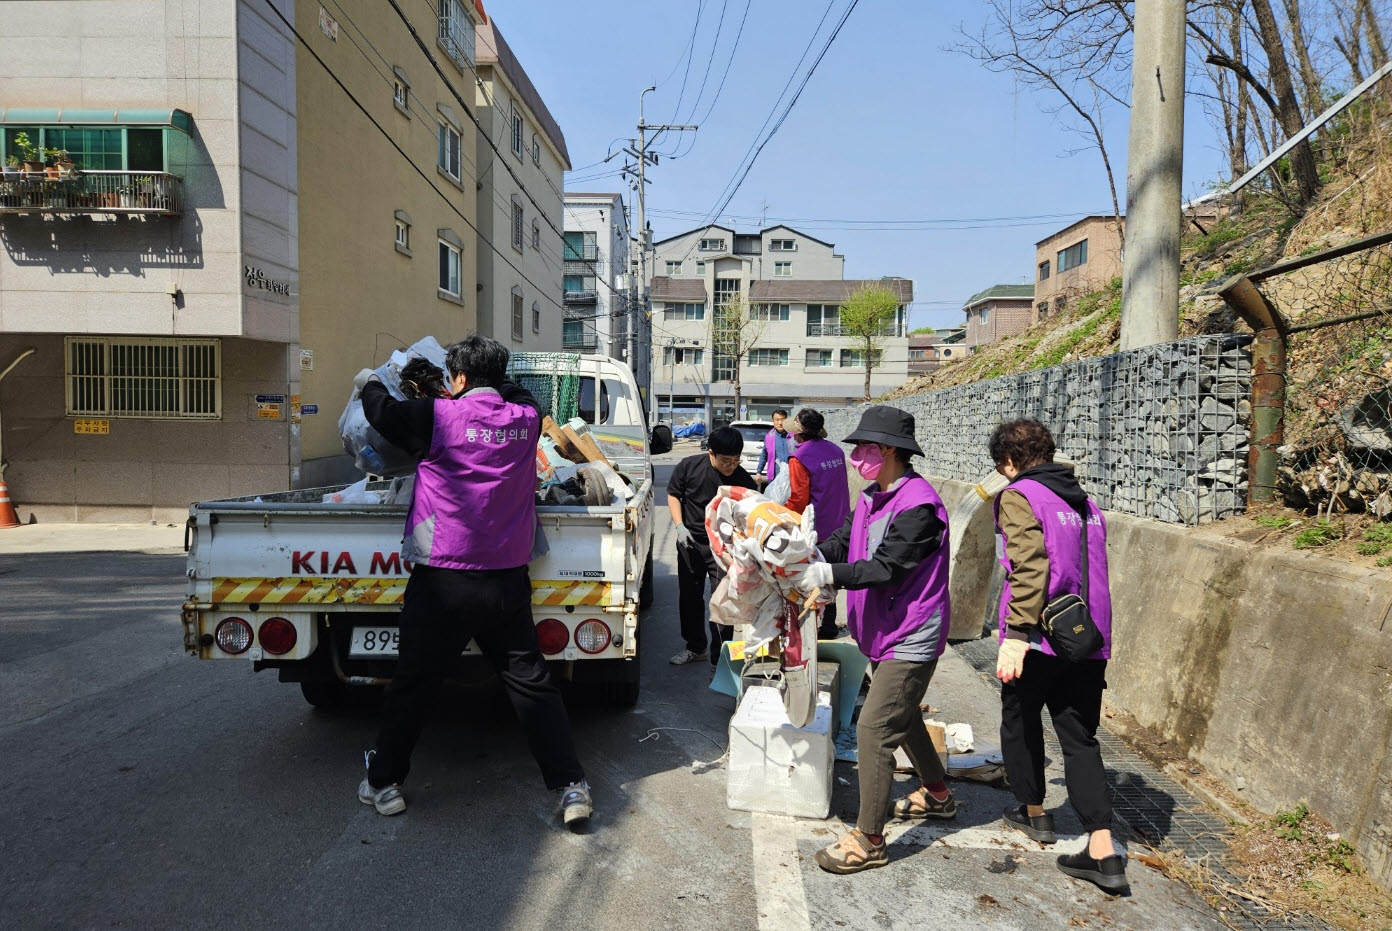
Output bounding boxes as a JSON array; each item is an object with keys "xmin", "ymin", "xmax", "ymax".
[{"xmin": 401, "ymin": 388, "xmax": 540, "ymax": 569}]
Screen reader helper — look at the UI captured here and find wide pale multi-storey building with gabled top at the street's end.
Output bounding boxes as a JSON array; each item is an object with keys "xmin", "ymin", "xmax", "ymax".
[{"xmin": 650, "ymin": 225, "xmax": 913, "ymax": 423}]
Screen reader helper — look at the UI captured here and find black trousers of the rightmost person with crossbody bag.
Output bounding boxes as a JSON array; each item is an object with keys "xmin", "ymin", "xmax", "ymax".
[{"xmin": 1001, "ymin": 650, "xmax": 1112, "ymax": 831}]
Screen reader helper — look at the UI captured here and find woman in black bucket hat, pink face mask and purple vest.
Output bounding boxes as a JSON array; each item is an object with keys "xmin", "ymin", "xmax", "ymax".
[{"xmin": 800, "ymin": 405, "xmax": 956, "ymax": 873}]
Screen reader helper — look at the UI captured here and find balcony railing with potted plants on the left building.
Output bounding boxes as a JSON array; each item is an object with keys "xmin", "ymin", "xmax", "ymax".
[{"xmin": 0, "ymin": 168, "xmax": 184, "ymax": 217}]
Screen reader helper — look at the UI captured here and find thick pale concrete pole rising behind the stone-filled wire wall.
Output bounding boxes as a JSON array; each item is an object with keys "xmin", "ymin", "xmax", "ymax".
[{"xmin": 1122, "ymin": 0, "xmax": 1185, "ymax": 349}]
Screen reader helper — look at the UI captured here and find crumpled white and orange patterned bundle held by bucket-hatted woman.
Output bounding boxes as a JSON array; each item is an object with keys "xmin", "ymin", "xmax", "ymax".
[{"xmin": 706, "ymin": 486, "xmax": 835, "ymax": 728}]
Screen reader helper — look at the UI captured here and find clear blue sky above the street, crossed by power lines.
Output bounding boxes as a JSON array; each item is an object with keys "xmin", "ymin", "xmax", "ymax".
[{"xmin": 486, "ymin": 0, "xmax": 1222, "ymax": 326}]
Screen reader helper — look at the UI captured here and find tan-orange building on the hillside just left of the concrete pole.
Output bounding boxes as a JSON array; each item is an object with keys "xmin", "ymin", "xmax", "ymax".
[{"xmin": 1031, "ymin": 214, "xmax": 1125, "ymax": 321}]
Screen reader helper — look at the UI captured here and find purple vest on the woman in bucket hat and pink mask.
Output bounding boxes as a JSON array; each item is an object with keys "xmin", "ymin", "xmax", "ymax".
[{"xmin": 846, "ymin": 472, "xmax": 952, "ymax": 662}]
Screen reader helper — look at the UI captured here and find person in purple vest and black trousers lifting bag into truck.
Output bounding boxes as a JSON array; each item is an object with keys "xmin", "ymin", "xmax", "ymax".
[{"xmin": 358, "ymin": 337, "xmax": 593, "ymax": 825}]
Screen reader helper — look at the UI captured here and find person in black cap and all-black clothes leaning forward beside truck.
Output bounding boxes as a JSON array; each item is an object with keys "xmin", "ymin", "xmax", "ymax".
[{"xmin": 667, "ymin": 427, "xmax": 754, "ymax": 667}]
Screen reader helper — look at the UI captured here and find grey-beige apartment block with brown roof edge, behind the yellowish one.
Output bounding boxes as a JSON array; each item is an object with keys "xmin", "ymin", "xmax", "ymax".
[{"xmin": 475, "ymin": 19, "xmax": 571, "ymax": 352}]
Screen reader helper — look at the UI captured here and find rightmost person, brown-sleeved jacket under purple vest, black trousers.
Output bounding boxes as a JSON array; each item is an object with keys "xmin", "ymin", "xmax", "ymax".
[{"xmin": 990, "ymin": 420, "xmax": 1130, "ymax": 895}]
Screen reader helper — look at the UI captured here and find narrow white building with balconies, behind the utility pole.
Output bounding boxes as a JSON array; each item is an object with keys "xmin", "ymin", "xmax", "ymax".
[{"xmin": 561, "ymin": 191, "xmax": 632, "ymax": 360}]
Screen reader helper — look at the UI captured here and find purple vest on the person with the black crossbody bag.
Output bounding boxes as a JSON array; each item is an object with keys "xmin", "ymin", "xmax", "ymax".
[{"xmin": 995, "ymin": 479, "xmax": 1112, "ymax": 660}]
